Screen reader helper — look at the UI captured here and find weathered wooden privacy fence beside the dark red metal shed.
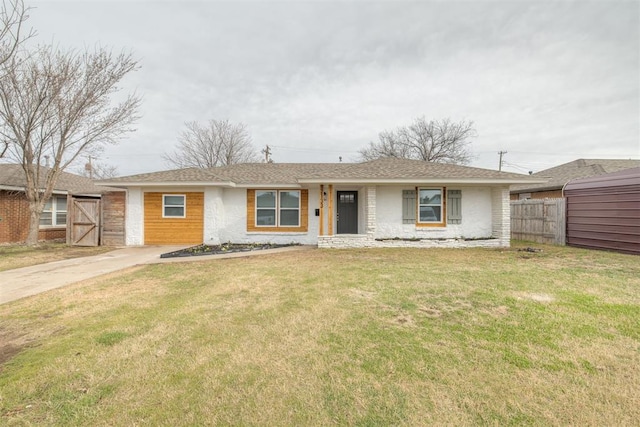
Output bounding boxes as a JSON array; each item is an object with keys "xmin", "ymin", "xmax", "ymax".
[{"xmin": 511, "ymin": 199, "xmax": 566, "ymax": 245}]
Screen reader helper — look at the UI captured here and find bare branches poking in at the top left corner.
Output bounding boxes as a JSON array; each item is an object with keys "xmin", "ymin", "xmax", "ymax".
[{"xmin": 0, "ymin": 0, "xmax": 34, "ymax": 158}]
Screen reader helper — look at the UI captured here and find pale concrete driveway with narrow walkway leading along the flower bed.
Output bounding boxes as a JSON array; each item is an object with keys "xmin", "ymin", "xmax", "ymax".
[{"xmin": 0, "ymin": 242, "xmax": 311, "ymax": 304}]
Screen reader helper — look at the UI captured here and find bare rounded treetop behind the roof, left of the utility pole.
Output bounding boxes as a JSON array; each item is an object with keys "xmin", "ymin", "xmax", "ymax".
[{"xmin": 162, "ymin": 120, "xmax": 259, "ymax": 168}]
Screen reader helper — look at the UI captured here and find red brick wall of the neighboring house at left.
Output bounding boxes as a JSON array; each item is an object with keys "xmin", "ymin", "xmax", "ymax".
[{"xmin": 0, "ymin": 190, "xmax": 67, "ymax": 244}]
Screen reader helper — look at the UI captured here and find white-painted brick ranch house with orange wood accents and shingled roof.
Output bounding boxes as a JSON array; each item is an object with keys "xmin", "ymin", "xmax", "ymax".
[{"xmin": 99, "ymin": 158, "xmax": 539, "ymax": 247}]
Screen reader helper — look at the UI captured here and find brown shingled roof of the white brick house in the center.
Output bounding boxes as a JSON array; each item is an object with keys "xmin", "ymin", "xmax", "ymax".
[{"xmin": 97, "ymin": 158, "xmax": 539, "ymax": 187}]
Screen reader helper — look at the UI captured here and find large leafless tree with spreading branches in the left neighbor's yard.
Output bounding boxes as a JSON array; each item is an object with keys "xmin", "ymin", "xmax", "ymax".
[{"xmin": 0, "ymin": 46, "xmax": 140, "ymax": 244}]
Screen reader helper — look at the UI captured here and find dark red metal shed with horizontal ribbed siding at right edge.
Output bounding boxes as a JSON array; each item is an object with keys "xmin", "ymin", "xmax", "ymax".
[{"xmin": 563, "ymin": 168, "xmax": 640, "ymax": 254}]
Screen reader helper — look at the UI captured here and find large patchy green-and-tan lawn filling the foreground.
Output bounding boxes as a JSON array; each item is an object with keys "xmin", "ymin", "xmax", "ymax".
[{"xmin": 0, "ymin": 245, "xmax": 640, "ymax": 426}]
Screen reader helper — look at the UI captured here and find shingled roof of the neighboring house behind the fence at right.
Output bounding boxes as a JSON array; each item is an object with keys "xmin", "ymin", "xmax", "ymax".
[{"xmin": 511, "ymin": 159, "xmax": 640, "ymax": 193}]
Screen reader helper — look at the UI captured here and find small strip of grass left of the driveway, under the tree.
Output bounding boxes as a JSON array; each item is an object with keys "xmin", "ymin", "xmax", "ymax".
[{"xmin": 0, "ymin": 243, "xmax": 113, "ymax": 271}]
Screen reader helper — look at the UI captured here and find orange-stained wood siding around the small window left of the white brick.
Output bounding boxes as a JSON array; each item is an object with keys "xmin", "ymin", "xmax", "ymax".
[{"xmin": 144, "ymin": 192, "xmax": 204, "ymax": 245}]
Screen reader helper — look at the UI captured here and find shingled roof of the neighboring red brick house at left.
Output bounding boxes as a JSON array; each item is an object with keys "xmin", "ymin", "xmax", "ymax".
[{"xmin": 0, "ymin": 164, "xmax": 114, "ymax": 195}]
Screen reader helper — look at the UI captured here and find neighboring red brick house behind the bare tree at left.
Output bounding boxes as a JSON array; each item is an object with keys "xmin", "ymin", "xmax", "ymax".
[{"xmin": 0, "ymin": 164, "xmax": 110, "ymax": 244}]
